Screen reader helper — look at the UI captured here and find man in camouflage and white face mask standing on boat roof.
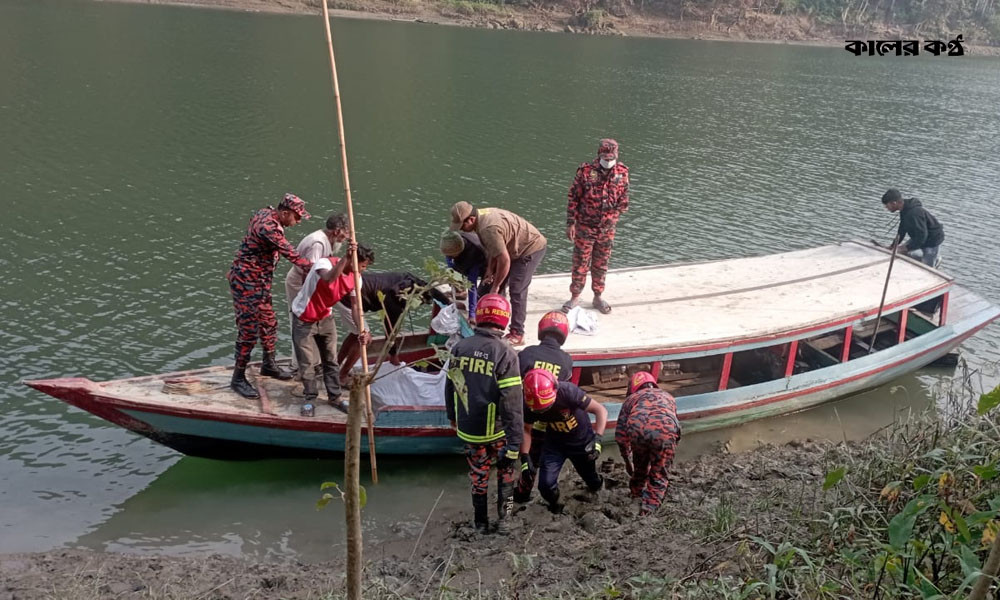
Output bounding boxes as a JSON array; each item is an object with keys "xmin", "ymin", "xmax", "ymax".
[{"xmin": 563, "ymin": 139, "xmax": 628, "ymax": 314}]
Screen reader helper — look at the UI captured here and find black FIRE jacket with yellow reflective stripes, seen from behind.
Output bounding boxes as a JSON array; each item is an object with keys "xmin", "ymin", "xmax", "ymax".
[{"xmin": 444, "ymin": 328, "xmax": 524, "ymax": 452}]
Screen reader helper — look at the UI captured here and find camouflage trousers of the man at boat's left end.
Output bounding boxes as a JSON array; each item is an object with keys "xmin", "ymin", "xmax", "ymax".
[{"xmin": 229, "ymin": 271, "xmax": 278, "ymax": 369}]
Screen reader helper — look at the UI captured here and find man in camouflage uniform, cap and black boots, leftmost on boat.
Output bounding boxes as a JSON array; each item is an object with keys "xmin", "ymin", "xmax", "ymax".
[{"xmin": 227, "ymin": 194, "xmax": 312, "ymax": 398}]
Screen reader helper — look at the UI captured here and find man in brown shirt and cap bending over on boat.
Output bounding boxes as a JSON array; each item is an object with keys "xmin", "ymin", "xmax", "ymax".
[{"xmin": 451, "ymin": 202, "xmax": 548, "ymax": 346}]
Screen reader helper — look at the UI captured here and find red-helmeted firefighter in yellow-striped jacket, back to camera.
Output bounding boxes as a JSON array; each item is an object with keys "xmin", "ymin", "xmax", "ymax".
[{"xmin": 444, "ymin": 294, "xmax": 524, "ymax": 534}]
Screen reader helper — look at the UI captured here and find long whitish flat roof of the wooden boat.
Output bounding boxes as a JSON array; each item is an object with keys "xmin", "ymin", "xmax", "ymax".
[{"xmin": 525, "ymin": 242, "xmax": 951, "ymax": 355}]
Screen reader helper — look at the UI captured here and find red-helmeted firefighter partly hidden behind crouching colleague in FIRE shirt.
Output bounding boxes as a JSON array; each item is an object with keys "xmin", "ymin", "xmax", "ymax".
[{"xmin": 514, "ymin": 310, "xmax": 573, "ymax": 502}]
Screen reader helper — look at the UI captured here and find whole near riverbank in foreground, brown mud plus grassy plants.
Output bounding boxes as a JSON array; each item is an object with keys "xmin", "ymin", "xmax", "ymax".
[{"xmin": 0, "ymin": 400, "xmax": 1000, "ymax": 600}]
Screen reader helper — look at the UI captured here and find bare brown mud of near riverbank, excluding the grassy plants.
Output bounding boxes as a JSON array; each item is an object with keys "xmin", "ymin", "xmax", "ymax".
[{"xmin": 0, "ymin": 442, "xmax": 834, "ymax": 600}]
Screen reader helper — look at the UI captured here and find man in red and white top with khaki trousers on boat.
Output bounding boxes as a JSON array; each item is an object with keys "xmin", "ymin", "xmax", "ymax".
[{"xmin": 291, "ymin": 242, "xmax": 375, "ymax": 417}]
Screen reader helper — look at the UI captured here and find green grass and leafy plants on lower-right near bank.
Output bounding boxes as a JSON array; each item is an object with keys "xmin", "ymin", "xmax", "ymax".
[{"xmin": 356, "ymin": 366, "xmax": 1000, "ymax": 600}]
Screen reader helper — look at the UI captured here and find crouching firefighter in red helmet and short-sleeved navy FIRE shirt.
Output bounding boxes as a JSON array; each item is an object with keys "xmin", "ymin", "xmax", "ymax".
[{"xmin": 521, "ymin": 369, "xmax": 608, "ymax": 513}]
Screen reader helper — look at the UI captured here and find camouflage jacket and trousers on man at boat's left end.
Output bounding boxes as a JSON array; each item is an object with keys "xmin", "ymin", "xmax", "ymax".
[{"xmin": 227, "ymin": 206, "xmax": 312, "ymax": 369}]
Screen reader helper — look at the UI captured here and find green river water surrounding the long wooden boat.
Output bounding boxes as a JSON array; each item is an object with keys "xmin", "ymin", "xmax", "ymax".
[{"xmin": 0, "ymin": 0, "xmax": 1000, "ymax": 560}]
